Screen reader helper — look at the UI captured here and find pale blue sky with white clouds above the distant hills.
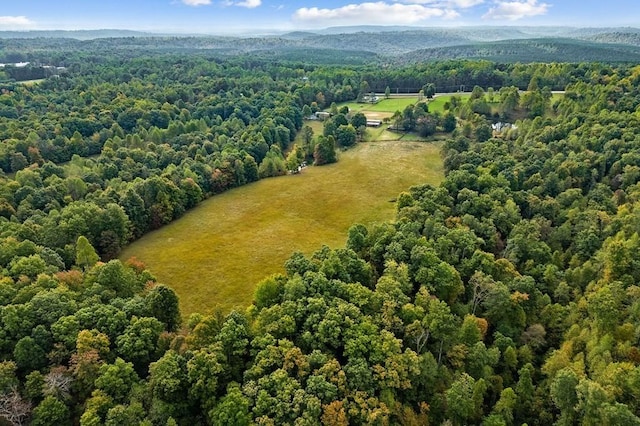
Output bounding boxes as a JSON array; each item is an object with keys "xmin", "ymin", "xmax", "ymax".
[{"xmin": 0, "ymin": 0, "xmax": 640, "ymax": 34}]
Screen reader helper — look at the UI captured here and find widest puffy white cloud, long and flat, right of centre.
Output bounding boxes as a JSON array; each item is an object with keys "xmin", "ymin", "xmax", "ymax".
[{"xmin": 293, "ymin": 1, "xmax": 459, "ymax": 27}]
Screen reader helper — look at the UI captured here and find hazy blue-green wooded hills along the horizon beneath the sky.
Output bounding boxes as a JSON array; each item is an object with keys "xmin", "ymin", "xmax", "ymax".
[{"xmin": 0, "ymin": 26, "xmax": 640, "ymax": 63}]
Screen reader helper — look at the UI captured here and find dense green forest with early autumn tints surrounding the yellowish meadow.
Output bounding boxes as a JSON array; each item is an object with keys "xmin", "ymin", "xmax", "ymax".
[{"xmin": 0, "ymin": 35, "xmax": 640, "ymax": 425}]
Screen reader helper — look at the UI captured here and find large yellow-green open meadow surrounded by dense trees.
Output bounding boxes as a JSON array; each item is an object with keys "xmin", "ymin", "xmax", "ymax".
[{"xmin": 121, "ymin": 141, "xmax": 442, "ymax": 316}]
